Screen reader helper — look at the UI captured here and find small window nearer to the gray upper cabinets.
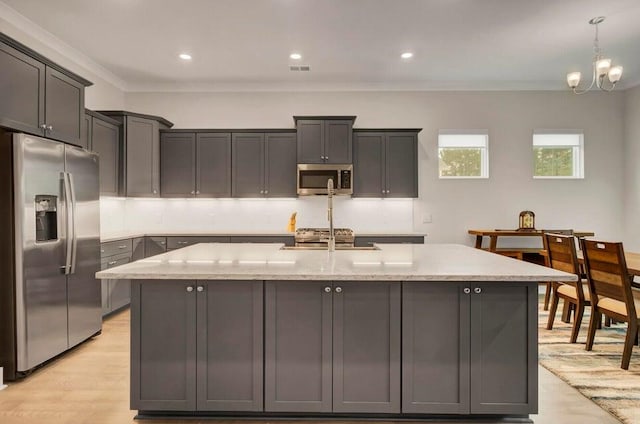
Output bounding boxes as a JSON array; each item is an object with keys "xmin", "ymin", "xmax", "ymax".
[{"xmin": 438, "ymin": 130, "xmax": 489, "ymax": 178}]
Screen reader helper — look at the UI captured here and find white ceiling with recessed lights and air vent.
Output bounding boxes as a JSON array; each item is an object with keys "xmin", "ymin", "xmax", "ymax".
[{"xmin": 0, "ymin": 0, "xmax": 640, "ymax": 91}]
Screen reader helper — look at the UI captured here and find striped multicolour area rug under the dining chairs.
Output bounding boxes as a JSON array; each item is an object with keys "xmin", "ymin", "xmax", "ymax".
[{"xmin": 538, "ymin": 302, "xmax": 640, "ymax": 424}]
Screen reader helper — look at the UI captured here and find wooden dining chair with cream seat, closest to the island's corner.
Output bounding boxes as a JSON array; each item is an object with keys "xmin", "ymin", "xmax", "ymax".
[{"xmin": 543, "ymin": 233, "xmax": 591, "ymax": 343}]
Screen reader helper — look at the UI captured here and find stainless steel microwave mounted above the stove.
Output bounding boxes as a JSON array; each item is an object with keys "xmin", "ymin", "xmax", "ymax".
[{"xmin": 297, "ymin": 163, "xmax": 353, "ymax": 196}]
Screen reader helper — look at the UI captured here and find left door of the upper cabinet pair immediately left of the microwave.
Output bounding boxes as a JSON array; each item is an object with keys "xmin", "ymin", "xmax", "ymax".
[{"xmin": 231, "ymin": 133, "xmax": 264, "ymax": 197}]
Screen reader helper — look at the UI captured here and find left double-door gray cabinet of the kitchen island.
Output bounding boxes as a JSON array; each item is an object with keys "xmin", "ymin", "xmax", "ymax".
[{"xmin": 131, "ymin": 280, "xmax": 263, "ymax": 411}]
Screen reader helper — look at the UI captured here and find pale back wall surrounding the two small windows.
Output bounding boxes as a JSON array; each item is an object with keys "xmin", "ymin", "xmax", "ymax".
[{"xmin": 120, "ymin": 92, "xmax": 625, "ymax": 244}]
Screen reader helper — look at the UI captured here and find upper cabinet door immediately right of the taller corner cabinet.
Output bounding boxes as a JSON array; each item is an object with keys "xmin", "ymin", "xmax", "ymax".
[{"xmin": 160, "ymin": 133, "xmax": 196, "ymax": 197}]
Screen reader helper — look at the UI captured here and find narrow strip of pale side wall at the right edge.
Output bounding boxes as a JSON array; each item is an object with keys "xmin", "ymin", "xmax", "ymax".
[{"xmin": 624, "ymin": 86, "xmax": 640, "ymax": 252}]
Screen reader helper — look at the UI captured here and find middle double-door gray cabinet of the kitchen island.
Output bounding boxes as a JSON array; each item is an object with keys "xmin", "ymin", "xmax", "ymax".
[{"xmin": 265, "ymin": 281, "xmax": 400, "ymax": 413}]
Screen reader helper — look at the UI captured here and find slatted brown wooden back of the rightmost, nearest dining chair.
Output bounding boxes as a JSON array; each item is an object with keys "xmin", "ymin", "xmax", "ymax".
[{"xmin": 582, "ymin": 239, "xmax": 635, "ymax": 313}]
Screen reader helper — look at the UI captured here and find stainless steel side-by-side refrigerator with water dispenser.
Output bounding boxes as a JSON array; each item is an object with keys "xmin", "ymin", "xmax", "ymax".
[{"xmin": 0, "ymin": 132, "xmax": 102, "ymax": 380}]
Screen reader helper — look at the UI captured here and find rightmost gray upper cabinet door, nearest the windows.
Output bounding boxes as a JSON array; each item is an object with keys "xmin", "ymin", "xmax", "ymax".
[{"xmin": 385, "ymin": 133, "xmax": 418, "ymax": 197}]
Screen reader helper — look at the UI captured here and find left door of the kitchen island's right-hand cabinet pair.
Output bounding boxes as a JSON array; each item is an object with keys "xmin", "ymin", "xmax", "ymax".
[{"xmin": 402, "ymin": 282, "xmax": 471, "ymax": 414}]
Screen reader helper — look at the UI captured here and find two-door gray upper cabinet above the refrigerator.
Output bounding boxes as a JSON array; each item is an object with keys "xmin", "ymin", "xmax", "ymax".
[{"xmin": 0, "ymin": 33, "xmax": 91, "ymax": 147}]
